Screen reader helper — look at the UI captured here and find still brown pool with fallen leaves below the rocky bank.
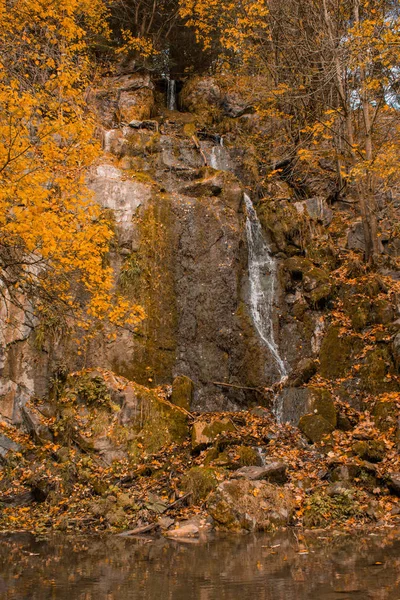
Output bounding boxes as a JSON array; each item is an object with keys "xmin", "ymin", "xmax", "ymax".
[{"xmin": 0, "ymin": 530, "xmax": 400, "ymax": 600}]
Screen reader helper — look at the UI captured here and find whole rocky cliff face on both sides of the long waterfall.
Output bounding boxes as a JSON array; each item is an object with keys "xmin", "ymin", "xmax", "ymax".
[{"xmin": 0, "ymin": 74, "xmax": 399, "ymax": 422}]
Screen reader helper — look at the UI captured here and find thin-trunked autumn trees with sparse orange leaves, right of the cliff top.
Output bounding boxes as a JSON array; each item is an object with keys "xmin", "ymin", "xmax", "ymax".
[{"xmin": 181, "ymin": 0, "xmax": 399, "ymax": 261}]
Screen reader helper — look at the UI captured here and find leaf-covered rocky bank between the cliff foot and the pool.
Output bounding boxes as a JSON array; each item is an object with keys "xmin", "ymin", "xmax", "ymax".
[{"xmin": 0, "ymin": 370, "xmax": 400, "ymax": 538}]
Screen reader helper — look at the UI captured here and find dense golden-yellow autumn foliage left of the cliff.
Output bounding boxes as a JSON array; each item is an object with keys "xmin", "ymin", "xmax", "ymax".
[{"xmin": 0, "ymin": 0, "xmax": 142, "ymax": 338}]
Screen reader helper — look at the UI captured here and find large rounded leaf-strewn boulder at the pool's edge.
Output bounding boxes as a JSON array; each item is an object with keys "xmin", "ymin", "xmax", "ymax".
[{"xmin": 207, "ymin": 479, "xmax": 294, "ymax": 531}]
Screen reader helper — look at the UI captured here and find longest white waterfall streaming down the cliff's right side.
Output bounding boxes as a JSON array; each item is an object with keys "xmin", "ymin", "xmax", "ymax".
[{"xmin": 244, "ymin": 194, "xmax": 287, "ymax": 380}]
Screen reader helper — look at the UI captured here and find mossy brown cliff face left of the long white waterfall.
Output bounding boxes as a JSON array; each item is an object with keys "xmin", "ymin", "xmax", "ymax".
[{"xmin": 0, "ymin": 75, "xmax": 290, "ymax": 421}]
